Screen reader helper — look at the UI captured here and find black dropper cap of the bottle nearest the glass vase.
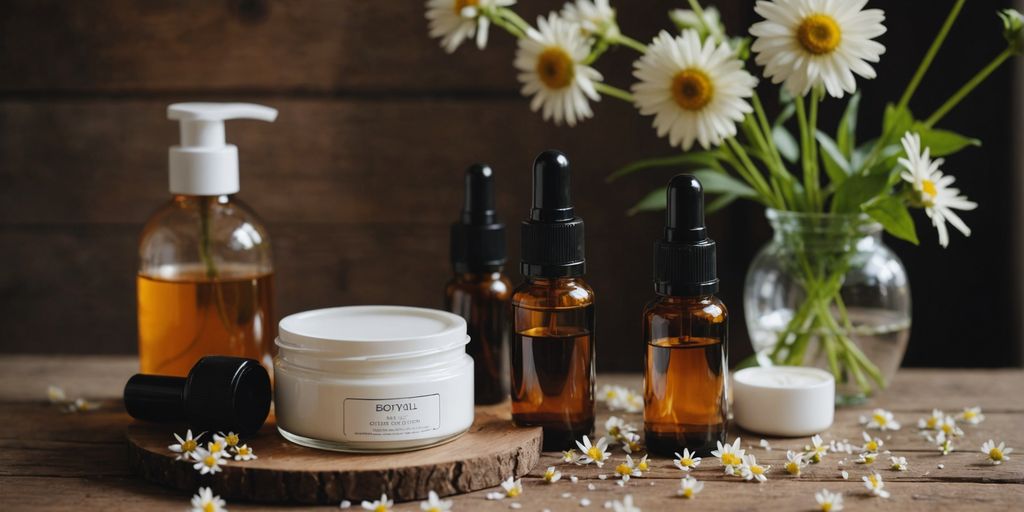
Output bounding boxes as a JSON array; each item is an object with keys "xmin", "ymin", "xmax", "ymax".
[{"xmin": 654, "ymin": 174, "xmax": 718, "ymax": 297}]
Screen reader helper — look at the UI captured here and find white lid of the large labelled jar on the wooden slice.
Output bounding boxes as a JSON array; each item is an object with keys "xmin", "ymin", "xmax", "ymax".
[{"xmin": 278, "ymin": 306, "xmax": 469, "ymax": 359}]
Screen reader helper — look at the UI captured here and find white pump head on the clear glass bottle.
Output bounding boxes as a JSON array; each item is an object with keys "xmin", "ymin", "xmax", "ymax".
[{"xmin": 167, "ymin": 103, "xmax": 278, "ymax": 196}]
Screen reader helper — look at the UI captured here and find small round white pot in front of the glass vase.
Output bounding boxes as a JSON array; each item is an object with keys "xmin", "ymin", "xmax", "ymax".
[{"xmin": 732, "ymin": 367, "xmax": 836, "ymax": 437}]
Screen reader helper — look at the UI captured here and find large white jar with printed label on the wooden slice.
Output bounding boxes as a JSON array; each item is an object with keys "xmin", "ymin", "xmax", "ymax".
[{"xmin": 273, "ymin": 306, "xmax": 473, "ymax": 452}]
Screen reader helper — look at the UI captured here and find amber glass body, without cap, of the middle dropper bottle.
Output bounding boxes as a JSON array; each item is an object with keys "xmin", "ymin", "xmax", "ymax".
[{"xmin": 511, "ymin": 278, "xmax": 595, "ymax": 451}]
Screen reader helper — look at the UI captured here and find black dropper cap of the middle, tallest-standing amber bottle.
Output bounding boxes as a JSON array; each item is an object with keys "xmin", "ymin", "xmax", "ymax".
[{"xmin": 520, "ymin": 150, "xmax": 587, "ymax": 279}]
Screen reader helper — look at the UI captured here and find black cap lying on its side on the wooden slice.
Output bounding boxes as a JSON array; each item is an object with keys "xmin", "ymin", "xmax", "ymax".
[{"xmin": 125, "ymin": 355, "xmax": 270, "ymax": 434}]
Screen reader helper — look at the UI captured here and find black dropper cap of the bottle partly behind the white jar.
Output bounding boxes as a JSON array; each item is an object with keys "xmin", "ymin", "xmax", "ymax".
[{"xmin": 452, "ymin": 164, "xmax": 506, "ymax": 273}]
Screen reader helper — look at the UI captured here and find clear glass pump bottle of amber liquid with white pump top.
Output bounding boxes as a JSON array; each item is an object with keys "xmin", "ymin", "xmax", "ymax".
[{"xmin": 136, "ymin": 103, "xmax": 278, "ymax": 376}]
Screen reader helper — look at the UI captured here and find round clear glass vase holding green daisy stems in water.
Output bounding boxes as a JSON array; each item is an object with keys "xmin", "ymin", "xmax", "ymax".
[{"xmin": 743, "ymin": 209, "xmax": 910, "ymax": 404}]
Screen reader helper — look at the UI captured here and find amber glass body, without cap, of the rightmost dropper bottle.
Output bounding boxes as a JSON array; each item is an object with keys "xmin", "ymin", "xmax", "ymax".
[{"xmin": 644, "ymin": 296, "xmax": 728, "ymax": 456}]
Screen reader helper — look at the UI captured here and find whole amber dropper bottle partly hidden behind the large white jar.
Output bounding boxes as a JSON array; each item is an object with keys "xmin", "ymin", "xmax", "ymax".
[{"xmin": 444, "ymin": 164, "xmax": 512, "ymax": 404}]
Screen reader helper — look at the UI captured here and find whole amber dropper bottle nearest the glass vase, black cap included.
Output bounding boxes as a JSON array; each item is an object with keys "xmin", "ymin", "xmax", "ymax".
[{"xmin": 643, "ymin": 174, "xmax": 728, "ymax": 456}]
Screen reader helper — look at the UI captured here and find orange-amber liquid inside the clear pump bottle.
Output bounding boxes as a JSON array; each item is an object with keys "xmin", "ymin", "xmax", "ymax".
[{"xmin": 137, "ymin": 265, "xmax": 275, "ymax": 376}]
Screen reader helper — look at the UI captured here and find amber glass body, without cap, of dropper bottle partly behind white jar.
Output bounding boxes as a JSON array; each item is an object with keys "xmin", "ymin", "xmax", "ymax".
[{"xmin": 444, "ymin": 271, "xmax": 512, "ymax": 404}]
